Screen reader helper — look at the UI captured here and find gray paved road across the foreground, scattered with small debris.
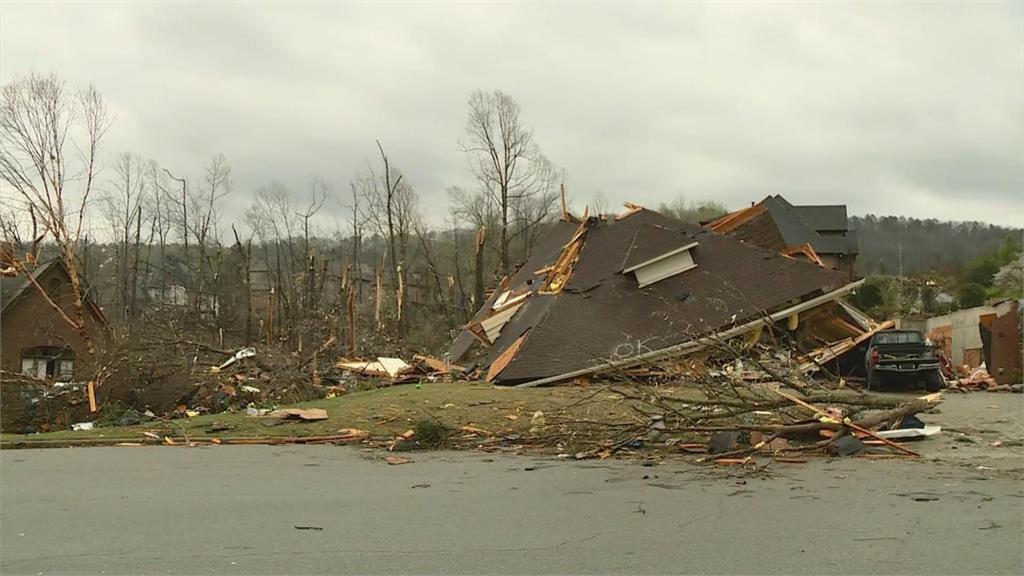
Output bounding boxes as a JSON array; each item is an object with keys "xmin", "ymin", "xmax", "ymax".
[{"xmin": 0, "ymin": 446, "xmax": 1024, "ymax": 574}]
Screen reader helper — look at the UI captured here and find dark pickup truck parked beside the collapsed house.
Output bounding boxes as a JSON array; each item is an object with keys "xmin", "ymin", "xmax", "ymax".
[{"xmin": 864, "ymin": 330, "xmax": 942, "ymax": 392}]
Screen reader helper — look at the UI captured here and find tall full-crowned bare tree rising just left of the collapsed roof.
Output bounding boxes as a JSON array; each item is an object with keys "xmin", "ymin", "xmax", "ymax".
[{"xmin": 462, "ymin": 90, "xmax": 557, "ymax": 275}]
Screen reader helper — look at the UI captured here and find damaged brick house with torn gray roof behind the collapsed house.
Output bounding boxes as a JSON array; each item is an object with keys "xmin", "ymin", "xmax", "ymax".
[{"xmin": 705, "ymin": 195, "xmax": 859, "ymax": 280}]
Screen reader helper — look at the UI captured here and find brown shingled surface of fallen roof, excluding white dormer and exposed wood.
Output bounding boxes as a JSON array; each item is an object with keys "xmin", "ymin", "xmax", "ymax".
[{"xmin": 451, "ymin": 209, "xmax": 848, "ymax": 383}]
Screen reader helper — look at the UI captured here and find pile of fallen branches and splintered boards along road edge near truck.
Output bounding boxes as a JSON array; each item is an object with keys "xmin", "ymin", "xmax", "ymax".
[{"xmin": 503, "ymin": 382, "xmax": 942, "ymax": 464}]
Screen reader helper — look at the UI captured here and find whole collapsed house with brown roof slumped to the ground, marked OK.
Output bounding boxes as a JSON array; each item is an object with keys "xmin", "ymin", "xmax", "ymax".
[{"xmin": 450, "ymin": 205, "xmax": 864, "ymax": 385}]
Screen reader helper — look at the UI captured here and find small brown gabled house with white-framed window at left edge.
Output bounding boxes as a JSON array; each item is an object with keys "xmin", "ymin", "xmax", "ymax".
[{"xmin": 0, "ymin": 258, "xmax": 108, "ymax": 381}]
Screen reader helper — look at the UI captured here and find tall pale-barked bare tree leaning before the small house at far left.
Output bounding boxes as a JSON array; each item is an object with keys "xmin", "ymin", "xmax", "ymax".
[{"xmin": 0, "ymin": 73, "xmax": 112, "ymax": 354}]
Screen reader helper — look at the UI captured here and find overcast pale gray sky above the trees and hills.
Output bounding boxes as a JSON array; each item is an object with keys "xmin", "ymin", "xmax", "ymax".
[{"xmin": 0, "ymin": 0, "xmax": 1024, "ymax": 230}]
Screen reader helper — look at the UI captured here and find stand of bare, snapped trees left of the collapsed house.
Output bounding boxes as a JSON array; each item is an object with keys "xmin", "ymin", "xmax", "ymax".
[{"xmin": 0, "ymin": 74, "xmax": 577, "ymax": 355}]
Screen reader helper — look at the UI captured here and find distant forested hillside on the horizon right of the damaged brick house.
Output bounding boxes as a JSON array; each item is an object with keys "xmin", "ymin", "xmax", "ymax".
[{"xmin": 850, "ymin": 214, "xmax": 1021, "ymax": 276}]
